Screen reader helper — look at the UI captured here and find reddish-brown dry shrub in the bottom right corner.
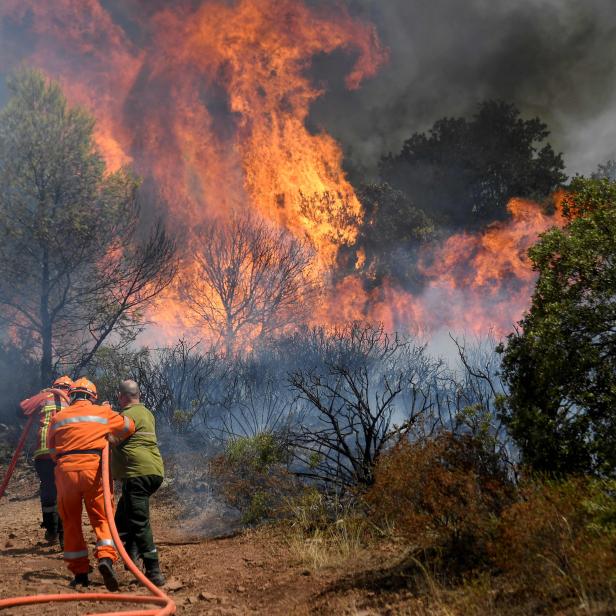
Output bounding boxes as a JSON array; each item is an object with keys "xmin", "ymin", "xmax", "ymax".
[{"xmin": 492, "ymin": 478, "xmax": 616, "ymax": 613}]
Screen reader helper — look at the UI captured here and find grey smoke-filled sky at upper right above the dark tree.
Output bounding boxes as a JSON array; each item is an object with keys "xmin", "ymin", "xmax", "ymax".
[{"xmin": 312, "ymin": 0, "xmax": 616, "ymax": 174}]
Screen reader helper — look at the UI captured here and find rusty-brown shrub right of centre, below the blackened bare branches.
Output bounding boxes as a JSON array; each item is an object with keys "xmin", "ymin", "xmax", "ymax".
[{"xmin": 365, "ymin": 433, "xmax": 513, "ymax": 575}]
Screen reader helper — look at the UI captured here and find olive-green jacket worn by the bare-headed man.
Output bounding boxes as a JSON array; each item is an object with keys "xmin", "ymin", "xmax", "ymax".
[{"xmin": 111, "ymin": 402, "xmax": 165, "ymax": 479}]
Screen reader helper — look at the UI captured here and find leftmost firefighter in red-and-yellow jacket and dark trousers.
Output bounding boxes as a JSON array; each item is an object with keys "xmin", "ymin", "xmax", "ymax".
[{"xmin": 20, "ymin": 376, "xmax": 73, "ymax": 545}]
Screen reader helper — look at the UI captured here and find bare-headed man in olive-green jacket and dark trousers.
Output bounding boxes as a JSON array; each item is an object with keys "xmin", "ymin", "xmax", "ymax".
[{"xmin": 111, "ymin": 380, "xmax": 165, "ymax": 586}]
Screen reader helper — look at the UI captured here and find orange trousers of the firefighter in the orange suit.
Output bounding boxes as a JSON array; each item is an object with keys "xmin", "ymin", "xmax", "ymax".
[{"xmin": 56, "ymin": 467, "xmax": 118, "ymax": 574}]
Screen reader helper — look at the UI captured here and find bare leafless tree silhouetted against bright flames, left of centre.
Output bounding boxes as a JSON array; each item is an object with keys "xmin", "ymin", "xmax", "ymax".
[{"xmin": 182, "ymin": 212, "xmax": 317, "ymax": 354}]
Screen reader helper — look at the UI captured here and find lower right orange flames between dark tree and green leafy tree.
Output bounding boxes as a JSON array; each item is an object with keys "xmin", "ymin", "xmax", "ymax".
[{"xmin": 315, "ymin": 192, "xmax": 565, "ymax": 336}]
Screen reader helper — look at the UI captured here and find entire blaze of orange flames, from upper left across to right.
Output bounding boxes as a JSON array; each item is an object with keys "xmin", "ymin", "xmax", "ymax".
[{"xmin": 0, "ymin": 0, "xmax": 558, "ymax": 337}]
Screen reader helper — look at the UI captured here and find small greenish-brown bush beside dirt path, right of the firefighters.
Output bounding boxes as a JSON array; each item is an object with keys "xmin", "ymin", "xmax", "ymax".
[{"xmin": 210, "ymin": 433, "xmax": 297, "ymax": 524}]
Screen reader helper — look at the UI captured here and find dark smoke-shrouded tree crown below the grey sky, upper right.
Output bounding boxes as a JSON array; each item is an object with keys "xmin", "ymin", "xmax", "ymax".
[{"xmin": 381, "ymin": 101, "xmax": 566, "ymax": 228}]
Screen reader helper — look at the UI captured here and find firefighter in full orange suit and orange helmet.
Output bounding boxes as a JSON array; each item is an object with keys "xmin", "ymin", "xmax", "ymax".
[{"xmin": 48, "ymin": 377, "xmax": 135, "ymax": 591}]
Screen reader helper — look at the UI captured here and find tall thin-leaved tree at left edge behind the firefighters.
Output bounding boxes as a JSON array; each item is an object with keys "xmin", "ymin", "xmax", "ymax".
[{"xmin": 0, "ymin": 70, "xmax": 175, "ymax": 385}]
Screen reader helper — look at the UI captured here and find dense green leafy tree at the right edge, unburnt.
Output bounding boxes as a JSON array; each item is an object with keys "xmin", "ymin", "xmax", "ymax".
[{"xmin": 503, "ymin": 178, "xmax": 616, "ymax": 475}]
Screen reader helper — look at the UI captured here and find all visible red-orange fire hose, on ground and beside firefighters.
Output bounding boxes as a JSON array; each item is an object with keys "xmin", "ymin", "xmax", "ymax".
[{"xmin": 0, "ymin": 422, "xmax": 176, "ymax": 616}]
